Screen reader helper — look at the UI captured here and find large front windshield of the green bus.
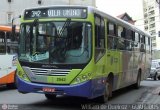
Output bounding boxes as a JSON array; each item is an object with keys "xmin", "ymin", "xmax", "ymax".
[{"xmin": 19, "ymin": 20, "xmax": 91, "ymax": 64}]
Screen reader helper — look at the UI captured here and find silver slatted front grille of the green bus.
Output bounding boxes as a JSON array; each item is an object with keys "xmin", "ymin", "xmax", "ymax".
[{"xmin": 30, "ymin": 68, "xmax": 71, "ymax": 76}]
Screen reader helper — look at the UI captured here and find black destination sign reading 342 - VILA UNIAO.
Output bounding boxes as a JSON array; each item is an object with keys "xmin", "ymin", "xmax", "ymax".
[{"xmin": 24, "ymin": 7, "xmax": 87, "ymax": 19}]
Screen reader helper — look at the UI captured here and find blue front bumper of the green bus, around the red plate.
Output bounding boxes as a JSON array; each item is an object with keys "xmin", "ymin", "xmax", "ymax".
[{"xmin": 17, "ymin": 77, "xmax": 92, "ymax": 98}]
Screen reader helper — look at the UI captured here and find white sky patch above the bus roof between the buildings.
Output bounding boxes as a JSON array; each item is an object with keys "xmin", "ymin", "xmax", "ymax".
[{"xmin": 96, "ymin": 0, "xmax": 143, "ymax": 26}]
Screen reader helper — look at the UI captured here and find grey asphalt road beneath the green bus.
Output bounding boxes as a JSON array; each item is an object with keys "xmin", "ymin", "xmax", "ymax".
[{"xmin": 0, "ymin": 79, "xmax": 160, "ymax": 110}]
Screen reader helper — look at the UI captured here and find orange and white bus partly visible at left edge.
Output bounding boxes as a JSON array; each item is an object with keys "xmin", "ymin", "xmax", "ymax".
[{"xmin": 0, "ymin": 25, "xmax": 19, "ymax": 88}]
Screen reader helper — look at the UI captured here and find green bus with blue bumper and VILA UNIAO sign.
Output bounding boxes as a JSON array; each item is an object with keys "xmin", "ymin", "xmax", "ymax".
[{"xmin": 16, "ymin": 6, "xmax": 151, "ymax": 102}]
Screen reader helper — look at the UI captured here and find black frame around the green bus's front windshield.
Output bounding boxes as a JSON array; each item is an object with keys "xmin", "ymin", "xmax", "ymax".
[{"xmin": 18, "ymin": 20, "xmax": 93, "ymax": 65}]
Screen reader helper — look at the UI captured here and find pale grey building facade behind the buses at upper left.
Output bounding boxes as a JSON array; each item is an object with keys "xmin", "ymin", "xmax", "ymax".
[{"xmin": 0, "ymin": 0, "xmax": 95, "ymax": 26}]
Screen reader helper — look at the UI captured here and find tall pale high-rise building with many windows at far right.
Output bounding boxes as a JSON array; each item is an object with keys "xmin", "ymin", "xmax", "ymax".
[{"xmin": 143, "ymin": 0, "xmax": 160, "ymax": 50}]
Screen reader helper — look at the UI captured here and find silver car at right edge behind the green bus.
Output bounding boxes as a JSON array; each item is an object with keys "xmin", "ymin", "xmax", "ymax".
[{"xmin": 149, "ymin": 60, "xmax": 160, "ymax": 80}]
